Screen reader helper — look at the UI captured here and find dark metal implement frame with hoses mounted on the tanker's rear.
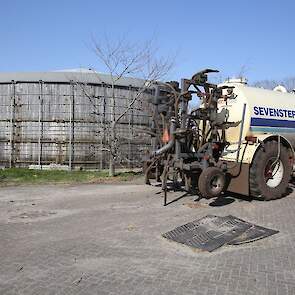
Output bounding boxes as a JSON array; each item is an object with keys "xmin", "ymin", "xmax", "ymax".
[{"xmin": 145, "ymin": 69, "xmax": 246, "ymax": 206}]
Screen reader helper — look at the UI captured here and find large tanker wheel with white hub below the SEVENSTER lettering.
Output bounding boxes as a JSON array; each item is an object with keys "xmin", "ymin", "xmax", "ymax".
[{"xmin": 249, "ymin": 141, "xmax": 293, "ymax": 201}]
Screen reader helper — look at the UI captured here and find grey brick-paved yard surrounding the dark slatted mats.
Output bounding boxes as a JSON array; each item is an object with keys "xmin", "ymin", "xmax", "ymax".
[{"xmin": 0, "ymin": 184, "xmax": 295, "ymax": 295}]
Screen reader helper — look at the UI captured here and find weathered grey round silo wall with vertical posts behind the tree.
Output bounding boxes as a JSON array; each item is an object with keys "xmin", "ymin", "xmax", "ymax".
[{"xmin": 0, "ymin": 81, "xmax": 150, "ymax": 169}]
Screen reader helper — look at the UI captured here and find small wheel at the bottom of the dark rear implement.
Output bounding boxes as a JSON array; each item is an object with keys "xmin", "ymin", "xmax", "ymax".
[{"xmin": 198, "ymin": 167, "xmax": 226, "ymax": 199}]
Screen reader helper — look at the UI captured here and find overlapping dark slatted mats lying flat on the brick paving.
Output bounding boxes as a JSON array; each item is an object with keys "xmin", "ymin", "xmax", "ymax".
[{"xmin": 163, "ymin": 215, "xmax": 278, "ymax": 252}]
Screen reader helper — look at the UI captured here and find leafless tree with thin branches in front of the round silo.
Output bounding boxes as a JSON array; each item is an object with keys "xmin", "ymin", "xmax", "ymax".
[{"xmin": 77, "ymin": 37, "xmax": 173, "ymax": 176}]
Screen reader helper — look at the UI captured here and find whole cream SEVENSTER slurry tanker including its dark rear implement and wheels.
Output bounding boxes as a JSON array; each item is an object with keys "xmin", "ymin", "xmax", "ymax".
[{"xmin": 144, "ymin": 69, "xmax": 295, "ymax": 204}]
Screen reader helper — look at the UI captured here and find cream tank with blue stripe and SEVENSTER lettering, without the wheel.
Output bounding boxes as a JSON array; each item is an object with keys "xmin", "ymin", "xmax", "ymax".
[{"xmin": 219, "ymin": 83, "xmax": 295, "ymax": 162}]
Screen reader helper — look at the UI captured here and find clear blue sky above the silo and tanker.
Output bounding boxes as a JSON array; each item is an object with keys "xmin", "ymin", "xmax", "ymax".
[{"xmin": 0, "ymin": 0, "xmax": 295, "ymax": 81}]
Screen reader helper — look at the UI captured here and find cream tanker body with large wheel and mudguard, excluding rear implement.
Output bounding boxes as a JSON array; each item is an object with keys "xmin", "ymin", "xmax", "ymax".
[{"xmin": 218, "ymin": 83, "xmax": 295, "ymax": 200}]
